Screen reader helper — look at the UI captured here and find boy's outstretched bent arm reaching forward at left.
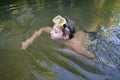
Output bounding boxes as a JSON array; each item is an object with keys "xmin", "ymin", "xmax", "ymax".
[{"xmin": 22, "ymin": 27, "xmax": 52, "ymax": 49}]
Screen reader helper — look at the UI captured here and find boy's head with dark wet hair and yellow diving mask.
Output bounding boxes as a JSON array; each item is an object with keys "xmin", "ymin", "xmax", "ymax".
[{"xmin": 51, "ymin": 15, "xmax": 75, "ymax": 39}]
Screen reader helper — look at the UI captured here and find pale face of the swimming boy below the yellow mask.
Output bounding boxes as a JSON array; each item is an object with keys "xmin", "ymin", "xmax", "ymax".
[{"xmin": 50, "ymin": 26, "xmax": 63, "ymax": 39}]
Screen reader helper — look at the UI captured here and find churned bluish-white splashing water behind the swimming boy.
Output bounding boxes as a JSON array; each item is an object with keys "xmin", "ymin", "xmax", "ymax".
[{"xmin": 89, "ymin": 26, "xmax": 120, "ymax": 70}]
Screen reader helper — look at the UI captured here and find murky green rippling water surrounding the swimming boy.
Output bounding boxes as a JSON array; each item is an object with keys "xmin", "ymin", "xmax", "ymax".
[{"xmin": 0, "ymin": 0, "xmax": 120, "ymax": 80}]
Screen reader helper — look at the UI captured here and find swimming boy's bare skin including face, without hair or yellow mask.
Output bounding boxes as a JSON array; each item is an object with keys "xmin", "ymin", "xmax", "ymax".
[{"xmin": 22, "ymin": 15, "xmax": 95, "ymax": 59}]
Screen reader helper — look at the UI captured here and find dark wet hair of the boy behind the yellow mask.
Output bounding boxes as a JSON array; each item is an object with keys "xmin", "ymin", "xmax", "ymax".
[{"xmin": 62, "ymin": 17, "xmax": 75, "ymax": 39}]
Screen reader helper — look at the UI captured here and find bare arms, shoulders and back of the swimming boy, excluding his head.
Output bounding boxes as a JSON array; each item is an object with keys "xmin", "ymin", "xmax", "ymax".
[{"xmin": 22, "ymin": 27, "xmax": 94, "ymax": 59}]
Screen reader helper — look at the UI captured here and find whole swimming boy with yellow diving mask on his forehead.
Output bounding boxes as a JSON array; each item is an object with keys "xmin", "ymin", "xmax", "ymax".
[{"xmin": 22, "ymin": 15, "xmax": 95, "ymax": 59}]
